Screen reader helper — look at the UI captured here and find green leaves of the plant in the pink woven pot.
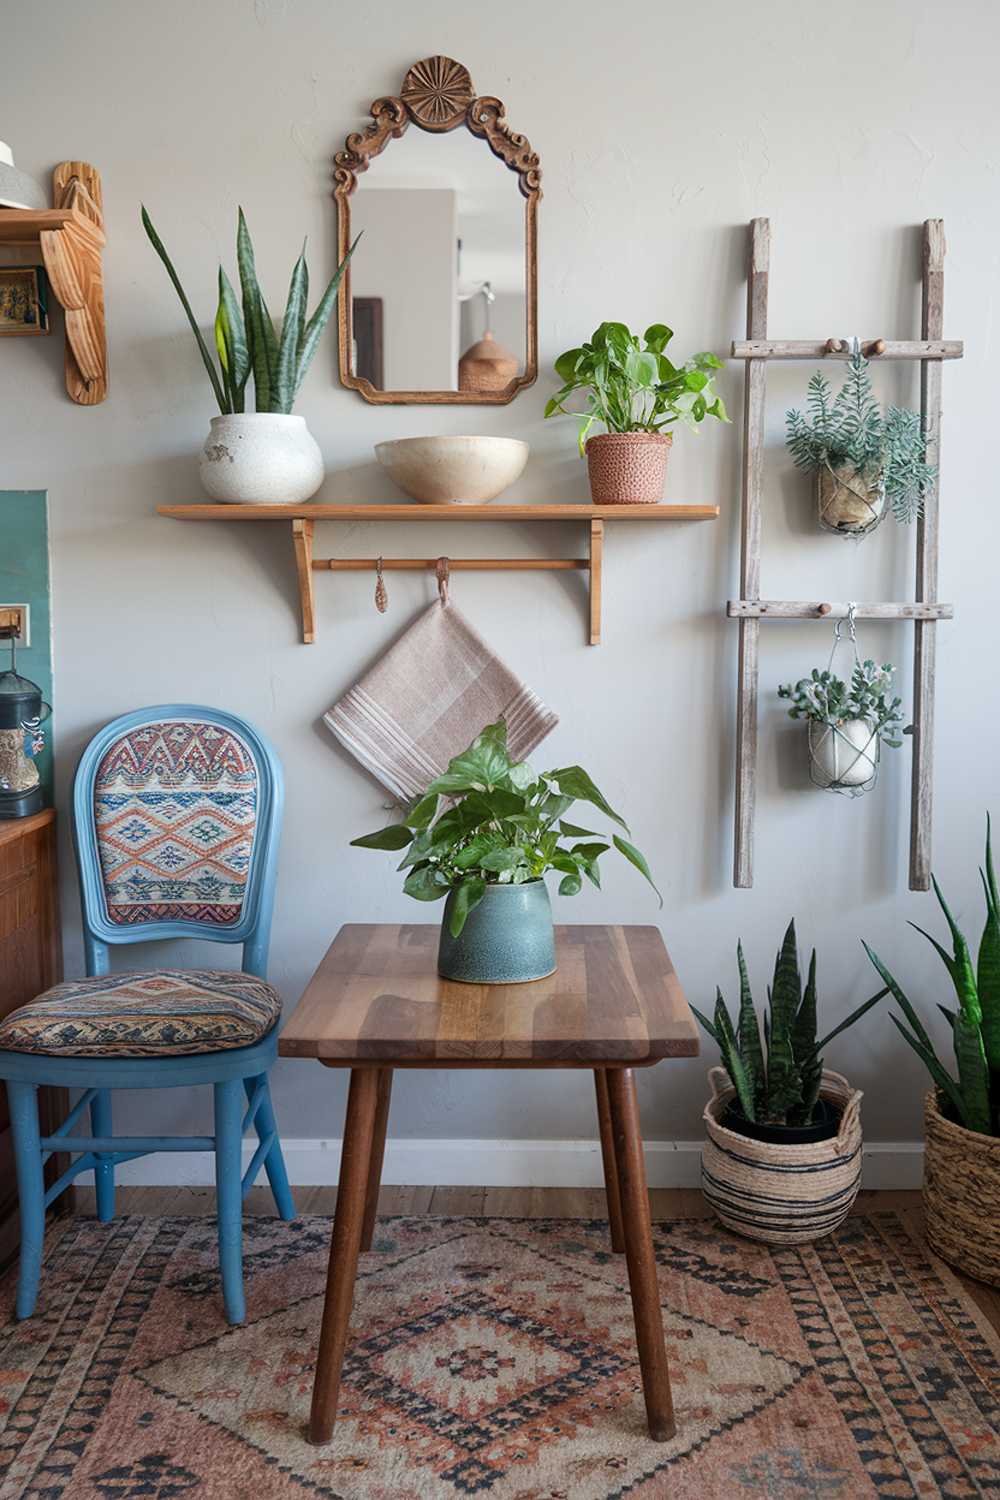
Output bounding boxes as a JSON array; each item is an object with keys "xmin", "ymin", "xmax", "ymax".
[{"xmin": 546, "ymin": 323, "xmax": 729, "ymax": 453}]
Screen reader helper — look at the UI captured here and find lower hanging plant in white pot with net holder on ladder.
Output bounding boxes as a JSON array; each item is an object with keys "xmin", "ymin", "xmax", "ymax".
[{"xmin": 778, "ymin": 605, "xmax": 907, "ymax": 797}]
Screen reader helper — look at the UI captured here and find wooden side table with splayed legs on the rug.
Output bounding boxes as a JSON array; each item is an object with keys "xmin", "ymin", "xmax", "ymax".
[{"xmin": 279, "ymin": 924, "xmax": 699, "ymax": 1443}]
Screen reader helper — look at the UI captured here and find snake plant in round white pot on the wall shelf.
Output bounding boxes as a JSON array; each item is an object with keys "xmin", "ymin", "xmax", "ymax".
[{"xmin": 142, "ymin": 209, "xmax": 357, "ymax": 504}]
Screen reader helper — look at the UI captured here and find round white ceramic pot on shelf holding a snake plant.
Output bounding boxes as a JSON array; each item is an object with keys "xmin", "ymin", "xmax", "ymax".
[{"xmin": 199, "ymin": 411, "xmax": 324, "ymax": 506}]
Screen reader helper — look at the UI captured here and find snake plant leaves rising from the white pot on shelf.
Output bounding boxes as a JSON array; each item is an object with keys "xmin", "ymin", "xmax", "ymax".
[{"xmin": 142, "ymin": 207, "xmax": 357, "ymax": 416}]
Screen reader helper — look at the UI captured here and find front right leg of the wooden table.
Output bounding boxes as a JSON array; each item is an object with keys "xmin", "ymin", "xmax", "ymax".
[{"xmin": 607, "ymin": 1068, "xmax": 676, "ymax": 1443}]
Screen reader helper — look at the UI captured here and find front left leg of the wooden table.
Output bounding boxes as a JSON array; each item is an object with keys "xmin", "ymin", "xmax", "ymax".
[{"xmin": 309, "ymin": 1068, "xmax": 379, "ymax": 1443}]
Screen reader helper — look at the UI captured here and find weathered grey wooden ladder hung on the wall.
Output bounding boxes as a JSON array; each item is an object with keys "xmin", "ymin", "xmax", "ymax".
[{"xmin": 726, "ymin": 219, "xmax": 963, "ymax": 891}]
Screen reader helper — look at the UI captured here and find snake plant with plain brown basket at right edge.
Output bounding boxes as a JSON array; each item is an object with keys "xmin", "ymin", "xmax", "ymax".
[{"xmin": 865, "ymin": 819, "xmax": 1000, "ymax": 1287}]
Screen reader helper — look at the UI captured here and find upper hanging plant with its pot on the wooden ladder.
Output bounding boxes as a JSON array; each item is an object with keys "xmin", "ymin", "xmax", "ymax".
[{"xmin": 786, "ymin": 353, "xmax": 937, "ymax": 537}]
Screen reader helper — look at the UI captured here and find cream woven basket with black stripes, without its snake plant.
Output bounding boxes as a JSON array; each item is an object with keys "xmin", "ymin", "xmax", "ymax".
[{"xmin": 702, "ymin": 1068, "xmax": 861, "ymax": 1245}]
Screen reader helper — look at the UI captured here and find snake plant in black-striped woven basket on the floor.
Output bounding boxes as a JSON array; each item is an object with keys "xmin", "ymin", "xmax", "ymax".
[{"xmin": 691, "ymin": 921, "xmax": 888, "ymax": 1245}]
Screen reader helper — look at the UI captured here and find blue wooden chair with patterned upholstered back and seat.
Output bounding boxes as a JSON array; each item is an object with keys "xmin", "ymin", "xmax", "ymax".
[{"xmin": 0, "ymin": 704, "xmax": 295, "ymax": 1323}]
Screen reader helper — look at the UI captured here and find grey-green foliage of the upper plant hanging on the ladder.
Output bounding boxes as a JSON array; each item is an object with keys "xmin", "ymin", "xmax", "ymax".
[{"xmin": 786, "ymin": 354, "xmax": 937, "ymax": 522}]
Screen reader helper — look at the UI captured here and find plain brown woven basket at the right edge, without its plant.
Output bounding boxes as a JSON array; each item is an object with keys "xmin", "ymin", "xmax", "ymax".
[{"xmin": 924, "ymin": 1092, "xmax": 1000, "ymax": 1287}]
